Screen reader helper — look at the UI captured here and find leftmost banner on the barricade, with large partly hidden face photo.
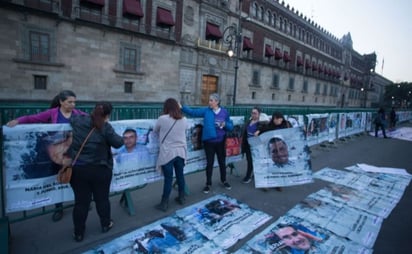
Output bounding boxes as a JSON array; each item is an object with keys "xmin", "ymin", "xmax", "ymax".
[{"xmin": 2, "ymin": 124, "xmax": 73, "ymax": 212}]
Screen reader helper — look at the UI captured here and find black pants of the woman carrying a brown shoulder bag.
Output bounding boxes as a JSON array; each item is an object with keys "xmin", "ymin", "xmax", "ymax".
[{"xmin": 70, "ymin": 165, "xmax": 112, "ymax": 234}]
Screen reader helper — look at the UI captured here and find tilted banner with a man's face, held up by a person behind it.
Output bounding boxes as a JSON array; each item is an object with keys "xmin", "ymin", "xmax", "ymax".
[{"xmin": 248, "ymin": 127, "xmax": 313, "ymax": 188}]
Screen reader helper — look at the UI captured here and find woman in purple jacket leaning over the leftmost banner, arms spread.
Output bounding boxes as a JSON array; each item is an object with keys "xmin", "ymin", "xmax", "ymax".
[{"xmin": 7, "ymin": 90, "xmax": 87, "ymax": 221}]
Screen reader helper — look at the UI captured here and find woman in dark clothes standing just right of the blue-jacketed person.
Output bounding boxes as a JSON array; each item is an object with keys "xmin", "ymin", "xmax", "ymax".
[{"xmin": 242, "ymin": 107, "xmax": 267, "ymax": 183}]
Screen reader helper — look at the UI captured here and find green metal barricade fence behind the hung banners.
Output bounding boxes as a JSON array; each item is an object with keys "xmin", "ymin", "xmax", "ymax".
[{"xmin": 0, "ymin": 103, "xmax": 376, "ymax": 253}]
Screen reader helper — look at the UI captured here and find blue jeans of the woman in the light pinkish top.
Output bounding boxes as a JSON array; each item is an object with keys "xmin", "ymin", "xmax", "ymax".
[{"xmin": 162, "ymin": 157, "xmax": 186, "ymax": 199}]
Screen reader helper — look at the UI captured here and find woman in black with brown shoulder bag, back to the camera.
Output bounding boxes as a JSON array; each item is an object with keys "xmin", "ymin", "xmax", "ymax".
[{"xmin": 64, "ymin": 102, "xmax": 123, "ymax": 242}]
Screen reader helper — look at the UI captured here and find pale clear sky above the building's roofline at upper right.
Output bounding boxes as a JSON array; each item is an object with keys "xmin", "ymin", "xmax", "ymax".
[{"xmin": 279, "ymin": 0, "xmax": 412, "ymax": 83}]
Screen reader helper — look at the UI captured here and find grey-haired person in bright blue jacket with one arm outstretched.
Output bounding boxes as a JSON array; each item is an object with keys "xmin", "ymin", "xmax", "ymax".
[{"xmin": 182, "ymin": 93, "xmax": 233, "ymax": 193}]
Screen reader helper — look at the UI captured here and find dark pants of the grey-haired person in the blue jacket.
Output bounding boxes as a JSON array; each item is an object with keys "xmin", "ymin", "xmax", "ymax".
[{"xmin": 203, "ymin": 140, "xmax": 226, "ymax": 185}]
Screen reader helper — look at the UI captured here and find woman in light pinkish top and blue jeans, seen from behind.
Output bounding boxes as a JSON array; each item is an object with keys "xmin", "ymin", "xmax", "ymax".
[{"xmin": 153, "ymin": 98, "xmax": 188, "ymax": 211}]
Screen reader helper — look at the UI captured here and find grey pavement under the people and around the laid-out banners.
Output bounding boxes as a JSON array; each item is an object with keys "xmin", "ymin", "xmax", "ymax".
[{"xmin": 10, "ymin": 124, "xmax": 412, "ymax": 254}]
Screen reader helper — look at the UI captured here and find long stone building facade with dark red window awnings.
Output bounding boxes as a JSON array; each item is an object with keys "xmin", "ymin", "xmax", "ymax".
[{"xmin": 0, "ymin": 0, "xmax": 391, "ymax": 107}]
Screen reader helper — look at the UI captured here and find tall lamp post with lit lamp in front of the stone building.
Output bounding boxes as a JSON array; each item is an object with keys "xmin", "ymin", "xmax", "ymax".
[{"xmin": 223, "ymin": 0, "xmax": 242, "ymax": 106}]
